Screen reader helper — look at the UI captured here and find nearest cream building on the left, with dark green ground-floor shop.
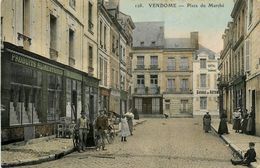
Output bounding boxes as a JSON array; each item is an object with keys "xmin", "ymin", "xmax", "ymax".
[{"xmin": 1, "ymin": 0, "xmax": 99, "ymax": 143}]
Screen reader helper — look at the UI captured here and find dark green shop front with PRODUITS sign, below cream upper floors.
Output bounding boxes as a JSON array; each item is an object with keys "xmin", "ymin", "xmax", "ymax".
[{"xmin": 1, "ymin": 43, "xmax": 98, "ymax": 143}]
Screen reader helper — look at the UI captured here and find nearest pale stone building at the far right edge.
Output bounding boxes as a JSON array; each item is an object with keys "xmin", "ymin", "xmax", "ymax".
[{"xmin": 244, "ymin": 0, "xmax": 260, "ymax": 136}]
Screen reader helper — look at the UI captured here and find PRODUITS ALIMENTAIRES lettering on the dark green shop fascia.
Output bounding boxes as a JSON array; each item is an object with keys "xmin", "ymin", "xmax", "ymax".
[{"xmin": 11, "ymin": 54, "xmax": 63, "ymax": 75}]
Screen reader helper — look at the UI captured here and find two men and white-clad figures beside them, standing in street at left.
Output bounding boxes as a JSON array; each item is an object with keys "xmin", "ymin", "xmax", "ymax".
[{"xmin": 76, "ymin": 107, "xmax": 134, "ymax": 152}]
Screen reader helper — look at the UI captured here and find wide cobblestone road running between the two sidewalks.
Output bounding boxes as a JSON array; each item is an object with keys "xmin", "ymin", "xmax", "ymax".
[{"xmin": 21, "ymin": 118, "xmax": 243, "ymax": 168}]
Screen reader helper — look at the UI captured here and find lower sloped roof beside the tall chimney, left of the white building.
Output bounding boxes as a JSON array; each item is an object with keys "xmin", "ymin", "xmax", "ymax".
[{"xmin": 164, "ymin": 38, "xmax": 192, "ymax": 48}]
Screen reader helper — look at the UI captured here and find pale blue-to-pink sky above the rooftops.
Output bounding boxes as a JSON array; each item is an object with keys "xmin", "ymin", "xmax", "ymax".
[{"xmin": 119, "ymin": 0, "xmax": 234, "ymax": 53}]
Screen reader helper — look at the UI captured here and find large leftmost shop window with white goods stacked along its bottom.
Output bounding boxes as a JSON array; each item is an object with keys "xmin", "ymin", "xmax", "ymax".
[{"xmin": 9, "ymin": 64, "xmax": 42, "ymax": 125}]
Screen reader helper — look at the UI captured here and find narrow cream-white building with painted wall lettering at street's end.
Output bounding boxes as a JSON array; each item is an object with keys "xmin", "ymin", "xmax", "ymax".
[{"xmin": 193, "ymin": 46, "xmax": 219, "ymax": 115}]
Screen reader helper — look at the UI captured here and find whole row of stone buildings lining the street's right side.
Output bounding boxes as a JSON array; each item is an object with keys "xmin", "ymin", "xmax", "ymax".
[{"xmin": 219, "ymin": 0, "xmax": 260, "ymax": 135}]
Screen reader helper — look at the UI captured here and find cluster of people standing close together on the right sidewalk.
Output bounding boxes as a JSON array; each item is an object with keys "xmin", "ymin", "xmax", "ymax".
[{"xmin": 233, "ymin": 108, "xmax": 255, "ymax": 135}]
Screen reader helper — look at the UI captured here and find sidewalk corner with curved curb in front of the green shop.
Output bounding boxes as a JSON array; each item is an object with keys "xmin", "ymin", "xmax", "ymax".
[{"xmin": 1, "ymin": 119, "xmax": 146, "ymax": 167}]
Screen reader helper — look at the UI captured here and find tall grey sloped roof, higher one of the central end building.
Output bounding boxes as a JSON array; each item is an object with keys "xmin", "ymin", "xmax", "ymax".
[{"xmin": 133, "ymin": 22, "xmax": 164, "ymax": 47}]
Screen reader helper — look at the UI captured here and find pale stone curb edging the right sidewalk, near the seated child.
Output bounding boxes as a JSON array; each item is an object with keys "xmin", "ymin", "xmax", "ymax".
[{"xmin": 211, "ymin": 125, "xmax": 260, "ymax": 168}]
